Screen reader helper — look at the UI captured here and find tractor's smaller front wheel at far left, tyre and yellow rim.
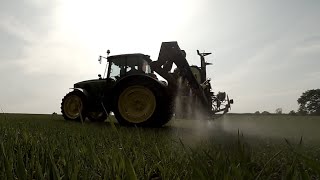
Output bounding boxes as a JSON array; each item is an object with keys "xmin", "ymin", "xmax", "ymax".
[{"xmin": 61, "ymin": 90, "xmax": 86, "ymax": 122}]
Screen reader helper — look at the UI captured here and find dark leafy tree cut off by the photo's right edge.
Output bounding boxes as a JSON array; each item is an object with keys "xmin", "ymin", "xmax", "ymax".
[{"xmin": 298, "ymin": 89, "xmax": 320, "ymax": 115}]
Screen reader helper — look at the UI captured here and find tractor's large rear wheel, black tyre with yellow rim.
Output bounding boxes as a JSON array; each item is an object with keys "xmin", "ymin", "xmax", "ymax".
[{"xmin": 113, "ymin": 76, "xmax": 172, "ymax": 127}]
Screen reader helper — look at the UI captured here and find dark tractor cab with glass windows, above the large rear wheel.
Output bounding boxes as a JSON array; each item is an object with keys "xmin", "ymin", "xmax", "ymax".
[{"xmin": 107, "ymin": 54, "xmax": 152, "ymax": 81}]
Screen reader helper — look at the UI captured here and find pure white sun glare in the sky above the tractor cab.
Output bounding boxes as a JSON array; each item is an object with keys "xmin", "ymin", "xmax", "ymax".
[{"xmin": 58, "ymin": 0, "xmax": 198, "ymax": 57}]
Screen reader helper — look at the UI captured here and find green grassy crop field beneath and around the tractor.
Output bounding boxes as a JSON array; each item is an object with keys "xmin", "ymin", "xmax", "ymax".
[{"xmin": 0, "ymin": 114, "xmax": 320, "ymax": 179}]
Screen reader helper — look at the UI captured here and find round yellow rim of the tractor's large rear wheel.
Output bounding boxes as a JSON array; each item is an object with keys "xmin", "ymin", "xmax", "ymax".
[{"xmin": 118, "ymin": 86, "xmax": 156, "ymax": 123}]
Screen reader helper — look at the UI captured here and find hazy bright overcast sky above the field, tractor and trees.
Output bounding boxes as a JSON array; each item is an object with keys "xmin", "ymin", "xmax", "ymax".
[{"xmin": 0, "ymin": 0, "xmax": 320, "ymax": 113}]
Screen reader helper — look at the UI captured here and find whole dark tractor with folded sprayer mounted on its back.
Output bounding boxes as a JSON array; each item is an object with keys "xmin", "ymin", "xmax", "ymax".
[{"xmin": 61, "ymin": 41, "xmax": 233, "ymax": 127}]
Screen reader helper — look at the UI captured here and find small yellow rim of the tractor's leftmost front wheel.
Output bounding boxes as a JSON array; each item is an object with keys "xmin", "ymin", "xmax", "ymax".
[{"xmin": 63, "ymin": 95, "xmax": 83, "ymax": 119}]
